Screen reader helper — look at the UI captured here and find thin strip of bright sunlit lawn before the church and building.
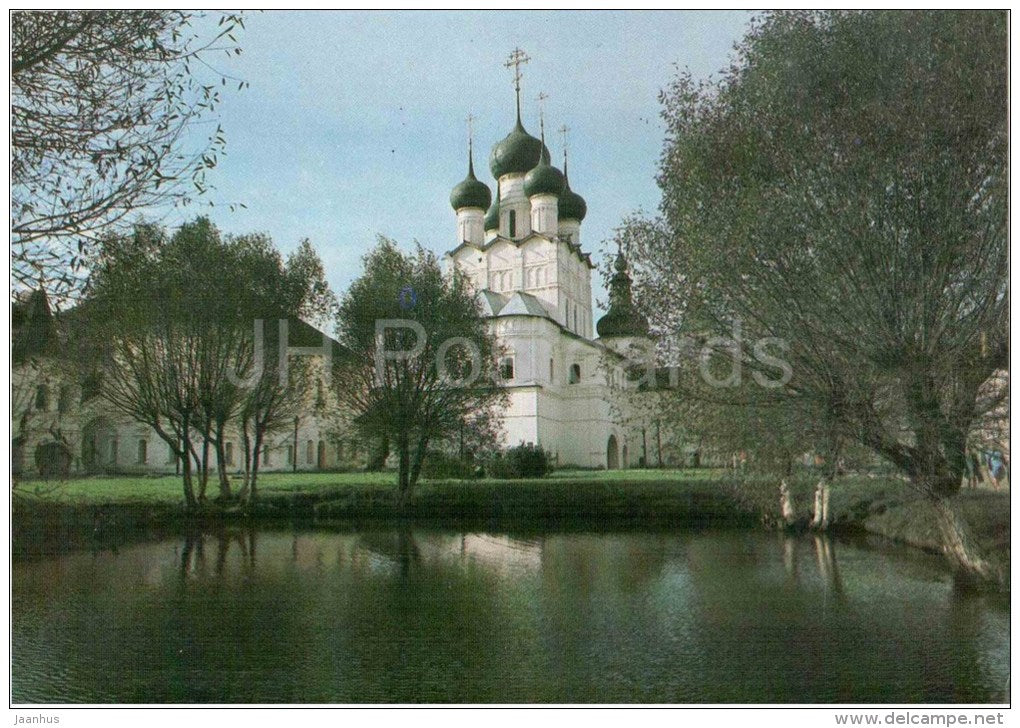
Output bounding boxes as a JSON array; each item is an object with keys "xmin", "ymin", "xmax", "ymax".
[{"xmin": 11, "ymin": 468, "xmax": 722, "ymax": 505}]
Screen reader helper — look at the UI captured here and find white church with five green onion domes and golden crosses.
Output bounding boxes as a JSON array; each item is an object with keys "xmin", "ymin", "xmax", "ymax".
[{"xmin": 446, "ymin": 51, "xmax": 662, "ymax": 468}]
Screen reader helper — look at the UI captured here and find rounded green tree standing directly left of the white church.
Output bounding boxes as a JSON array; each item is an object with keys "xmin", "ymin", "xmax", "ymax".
[{"xmin": 333, "ymin": 238, "xmax": 505, "ymax": 505}]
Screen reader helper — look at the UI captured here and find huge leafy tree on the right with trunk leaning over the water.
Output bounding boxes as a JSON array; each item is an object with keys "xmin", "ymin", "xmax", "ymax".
[{"xmin": 624, "ymin": 11, "xmax": 1009, "ymax": 578}]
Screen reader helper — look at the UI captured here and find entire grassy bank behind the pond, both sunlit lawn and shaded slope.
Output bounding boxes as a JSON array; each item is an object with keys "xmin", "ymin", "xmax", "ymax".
[{"xmin": 12, "ymin": 469, "xmax": 1010, "ymax": 573}]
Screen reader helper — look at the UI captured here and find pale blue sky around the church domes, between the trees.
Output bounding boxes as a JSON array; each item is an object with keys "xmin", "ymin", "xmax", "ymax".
[{"xmin": 173, "ymin": 11, "xmax": 750, "ymax": 315}]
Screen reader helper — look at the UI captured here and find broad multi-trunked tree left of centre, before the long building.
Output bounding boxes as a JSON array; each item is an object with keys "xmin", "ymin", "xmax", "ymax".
[{"xmin": 82, "ymin": 218, "xmax": 322, "ymax": 508}]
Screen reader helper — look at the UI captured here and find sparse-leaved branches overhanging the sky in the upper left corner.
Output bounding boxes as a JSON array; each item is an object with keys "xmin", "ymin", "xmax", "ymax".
[{"xmin": 10, "ymin": 10, "xmax": 244, "ymax": 296}]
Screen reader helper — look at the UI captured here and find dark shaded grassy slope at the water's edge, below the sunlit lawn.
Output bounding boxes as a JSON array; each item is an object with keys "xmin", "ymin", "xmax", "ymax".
[{"xmin": 11, "ymin": 471, "xmax": 1010, "ymax": 590}]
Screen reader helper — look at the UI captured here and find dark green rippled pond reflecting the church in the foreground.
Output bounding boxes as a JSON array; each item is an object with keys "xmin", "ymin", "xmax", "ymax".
[{"xmin": 11, "ymin": 528, "xmax": 1010, "ymax": 704}]
